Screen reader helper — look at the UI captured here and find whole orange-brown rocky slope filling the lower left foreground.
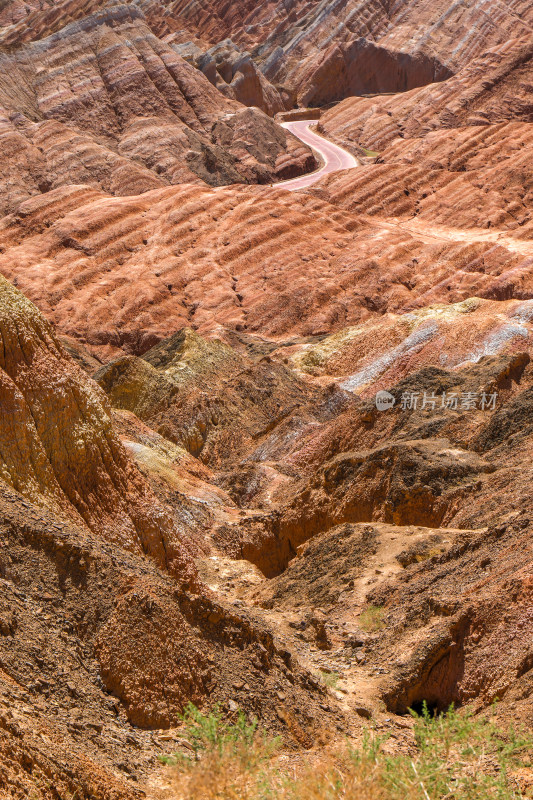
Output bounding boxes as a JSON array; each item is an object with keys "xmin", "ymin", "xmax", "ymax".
[{"xmin": 0, "ymin": 247, "xmax": 335, "ymax": 800}]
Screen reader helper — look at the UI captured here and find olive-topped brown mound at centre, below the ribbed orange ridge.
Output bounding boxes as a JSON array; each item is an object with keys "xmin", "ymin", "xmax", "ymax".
[{"xmin": 94, "ymin": 329, "xmax": 316, "ymax": 468}]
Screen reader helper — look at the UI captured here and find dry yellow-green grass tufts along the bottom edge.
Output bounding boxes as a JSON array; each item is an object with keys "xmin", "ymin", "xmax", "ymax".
[{"xmin": 162, "ymin": 706, "xmax": 533, "ymax": 800}]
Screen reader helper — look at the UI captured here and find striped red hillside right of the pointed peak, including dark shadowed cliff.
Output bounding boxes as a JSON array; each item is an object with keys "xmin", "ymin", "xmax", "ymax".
[{"xmin": 160, "ymin": 0, "xmax": 533, "ymax": 105}]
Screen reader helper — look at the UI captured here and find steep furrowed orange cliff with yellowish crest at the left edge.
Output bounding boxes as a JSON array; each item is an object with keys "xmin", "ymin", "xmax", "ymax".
[{"xmin": 0, "ymin": 278, "xmax": 196, "ymax": 585}]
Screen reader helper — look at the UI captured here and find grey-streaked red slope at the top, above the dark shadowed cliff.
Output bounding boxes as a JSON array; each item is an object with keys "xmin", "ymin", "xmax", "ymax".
[{"xmin": 139, "ymin": 0, "xmax": 531, "ymax": 68}]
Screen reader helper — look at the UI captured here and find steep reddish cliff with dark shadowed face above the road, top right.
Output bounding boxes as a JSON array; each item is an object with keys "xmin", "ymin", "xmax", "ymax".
[{"xmin": 266, "ymin": 0, "xmax": 533, "ymax": 105}]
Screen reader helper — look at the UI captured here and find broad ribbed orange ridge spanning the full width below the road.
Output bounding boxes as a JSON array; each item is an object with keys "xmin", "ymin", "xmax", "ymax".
[{"xmin": 0, "ymin": 180, "xmax": 532, "ymax": 355}]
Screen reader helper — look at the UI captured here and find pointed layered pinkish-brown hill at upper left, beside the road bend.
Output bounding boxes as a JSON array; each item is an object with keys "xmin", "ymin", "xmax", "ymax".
[{"xmin": 0, "ymin": 5, "xmax": 315, "ymax": 217}]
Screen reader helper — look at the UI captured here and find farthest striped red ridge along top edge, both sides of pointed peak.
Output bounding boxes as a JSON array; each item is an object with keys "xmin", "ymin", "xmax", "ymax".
[{"xmin": 4, "ymin": 0, "xmax": 533, "ymax": 107}]
